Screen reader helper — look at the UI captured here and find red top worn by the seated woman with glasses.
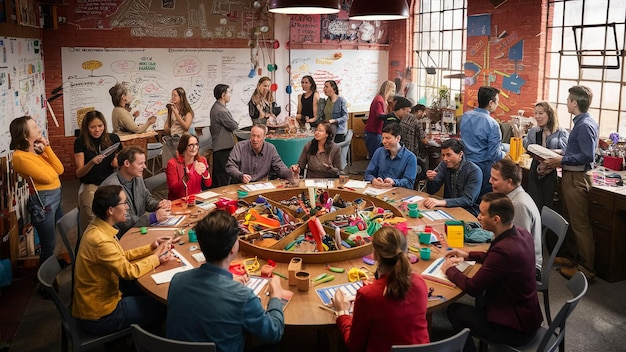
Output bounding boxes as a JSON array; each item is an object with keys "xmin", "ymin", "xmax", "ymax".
[{"xmin": 165, "ymin": 153, "xmax": 213, "ymax": 200}]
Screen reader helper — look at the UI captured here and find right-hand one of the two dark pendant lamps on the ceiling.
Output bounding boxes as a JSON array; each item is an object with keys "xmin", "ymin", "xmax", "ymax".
[{"xmin": 349, "ymin": 0, "xmax": 409, "ymax": 21}]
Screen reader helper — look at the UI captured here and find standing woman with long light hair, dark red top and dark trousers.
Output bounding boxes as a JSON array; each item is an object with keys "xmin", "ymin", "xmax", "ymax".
[{"xmin": 365, "ymin": 81, "xmax": 396, "ymax": 159}]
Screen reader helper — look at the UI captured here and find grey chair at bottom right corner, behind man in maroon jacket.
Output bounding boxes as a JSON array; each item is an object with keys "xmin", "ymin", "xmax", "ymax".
[{"xmin": 479, "ymin": 272, "xmax": 588, "ymax": 352}]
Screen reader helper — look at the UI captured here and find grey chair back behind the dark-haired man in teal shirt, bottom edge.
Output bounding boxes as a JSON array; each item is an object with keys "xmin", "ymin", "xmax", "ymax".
[{"xmin": 131, "ymin": 324, "xmax": 217, "ymax": 352}]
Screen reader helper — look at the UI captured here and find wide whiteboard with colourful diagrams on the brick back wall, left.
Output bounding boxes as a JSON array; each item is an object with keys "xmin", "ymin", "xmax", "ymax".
[{"xmin": 61, "ymin": 47, "xmax": 259, "ymax": 136}]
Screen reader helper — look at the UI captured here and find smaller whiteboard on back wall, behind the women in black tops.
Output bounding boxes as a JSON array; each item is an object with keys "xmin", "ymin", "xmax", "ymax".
[{"xmin": 290, "ymin": 50, "xmax": 389, "ymax": 111}]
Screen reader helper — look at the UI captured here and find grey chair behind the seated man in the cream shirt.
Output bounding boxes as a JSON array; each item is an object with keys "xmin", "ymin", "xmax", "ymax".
[{"xmin": 537, "ymin": 206, "xmax": 569, "ymax": 324}]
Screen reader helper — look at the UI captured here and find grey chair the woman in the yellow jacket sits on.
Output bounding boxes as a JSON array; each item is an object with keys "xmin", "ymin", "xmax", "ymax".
[{"xmin": 37, "ymin": 256, "xmax": 131, "ymax": 351}]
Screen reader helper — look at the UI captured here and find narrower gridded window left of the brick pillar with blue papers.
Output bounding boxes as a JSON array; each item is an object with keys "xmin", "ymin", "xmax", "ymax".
[{"xmin": 412, "ymin": 0, "xmax": 467, "ymax": 106}]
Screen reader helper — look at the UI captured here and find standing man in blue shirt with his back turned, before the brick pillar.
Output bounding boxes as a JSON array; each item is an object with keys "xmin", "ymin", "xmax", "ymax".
[{"xmin": 460, "ymin": 87, "xmax": 505, "ymax": 196}]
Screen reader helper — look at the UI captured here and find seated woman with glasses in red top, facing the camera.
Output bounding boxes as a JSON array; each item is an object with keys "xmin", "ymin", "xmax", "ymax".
[{"xmin": 165, "ymin": 132, "xmax": 212, "ymax": 200}]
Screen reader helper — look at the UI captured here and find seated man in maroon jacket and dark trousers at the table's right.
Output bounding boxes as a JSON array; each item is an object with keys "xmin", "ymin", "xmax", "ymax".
[{"xmin": 441, "ymin": 192, "xmax": 543, "ymax": 351}]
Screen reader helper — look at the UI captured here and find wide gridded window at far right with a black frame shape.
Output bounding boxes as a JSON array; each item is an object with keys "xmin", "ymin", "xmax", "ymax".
[{"xmin": 544, "ymin": 0, "xmax": 626, "ymax": 136}]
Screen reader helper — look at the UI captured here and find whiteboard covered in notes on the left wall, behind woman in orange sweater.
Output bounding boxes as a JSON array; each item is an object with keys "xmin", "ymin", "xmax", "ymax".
[{"xmin": 0, "ymin": 37, "xmax": 48, "ymax": 156}]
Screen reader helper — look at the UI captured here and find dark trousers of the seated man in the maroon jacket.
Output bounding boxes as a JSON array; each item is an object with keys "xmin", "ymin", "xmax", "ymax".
[{"xmin": 448, "ymin": 303, "xmax": 536, "ymax": 352}]
